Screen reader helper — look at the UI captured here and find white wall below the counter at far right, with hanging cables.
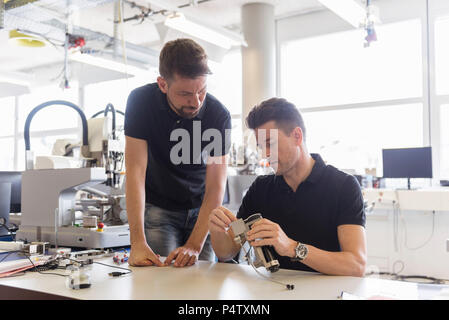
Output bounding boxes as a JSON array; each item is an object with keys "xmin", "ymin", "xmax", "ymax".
[{"xmin": 366, "ymin": 209, "xmax": 449, "ymax": 279}]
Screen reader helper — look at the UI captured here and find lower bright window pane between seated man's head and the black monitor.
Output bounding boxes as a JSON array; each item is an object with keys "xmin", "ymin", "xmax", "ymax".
[{"xmin": 303, "ymin": 104, "xmax": 423, "ymax": 176}]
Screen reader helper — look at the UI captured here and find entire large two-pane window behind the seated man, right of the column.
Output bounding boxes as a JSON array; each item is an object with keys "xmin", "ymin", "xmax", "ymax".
[{"xmin": 280, "ymin": 20, "xmax": 424, "ymax": 176}]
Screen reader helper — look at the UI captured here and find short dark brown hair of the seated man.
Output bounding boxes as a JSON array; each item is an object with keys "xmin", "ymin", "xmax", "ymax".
[{"xmin": 246, "ymin": 98, "xmax": 306, "ymax": 141}]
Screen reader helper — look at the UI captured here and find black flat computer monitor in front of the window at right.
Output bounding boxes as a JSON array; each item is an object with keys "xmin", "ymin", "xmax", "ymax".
[{"xmin": 382, "ymin": 147, "xmax": 433, "ymax": 189}]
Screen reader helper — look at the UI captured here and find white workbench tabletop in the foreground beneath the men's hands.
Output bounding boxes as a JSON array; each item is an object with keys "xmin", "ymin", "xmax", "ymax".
[{"xmin": 0, "ymin": 258, "xmax": 446, "ymax": 300}]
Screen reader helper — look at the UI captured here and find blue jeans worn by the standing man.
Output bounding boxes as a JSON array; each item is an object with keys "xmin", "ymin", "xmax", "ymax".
[{"xmin": 145, "ymin": 203, "xmax": 215, "ymax": 261}]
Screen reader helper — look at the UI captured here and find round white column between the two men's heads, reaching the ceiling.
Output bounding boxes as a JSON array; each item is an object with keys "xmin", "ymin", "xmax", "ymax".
[{"xmin": 242, "ymin": 3, "xmax": 276, "ymax": 131}]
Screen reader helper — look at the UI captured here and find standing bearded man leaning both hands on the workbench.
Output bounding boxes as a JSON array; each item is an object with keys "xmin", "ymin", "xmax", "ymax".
[{"xmin": 125, "ymin": 39, "xmax": 231, "ymax": 267}]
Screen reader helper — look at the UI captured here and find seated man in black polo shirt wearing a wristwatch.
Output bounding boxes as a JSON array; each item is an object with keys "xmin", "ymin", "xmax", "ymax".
[{"xmin": 209, "ymin": 98, "xmax": 366, "ymax": 276}]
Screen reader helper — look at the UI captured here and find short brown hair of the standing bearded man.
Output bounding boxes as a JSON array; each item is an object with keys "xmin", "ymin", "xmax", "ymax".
[{"xmin": 159, "ymin": 39, "xmax": 212, "ymax": 80}]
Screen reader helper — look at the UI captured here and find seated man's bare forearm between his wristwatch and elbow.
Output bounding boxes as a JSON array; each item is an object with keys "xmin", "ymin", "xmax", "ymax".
[{"xmin": 296, "ymin": 245, "xmax": 366, "ymax": 277}]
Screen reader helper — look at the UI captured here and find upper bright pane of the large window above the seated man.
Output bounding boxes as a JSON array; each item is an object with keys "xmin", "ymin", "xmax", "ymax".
[{"xmin": 281, "ymin": 20, "xmax": 422, "ymax": 107}]
